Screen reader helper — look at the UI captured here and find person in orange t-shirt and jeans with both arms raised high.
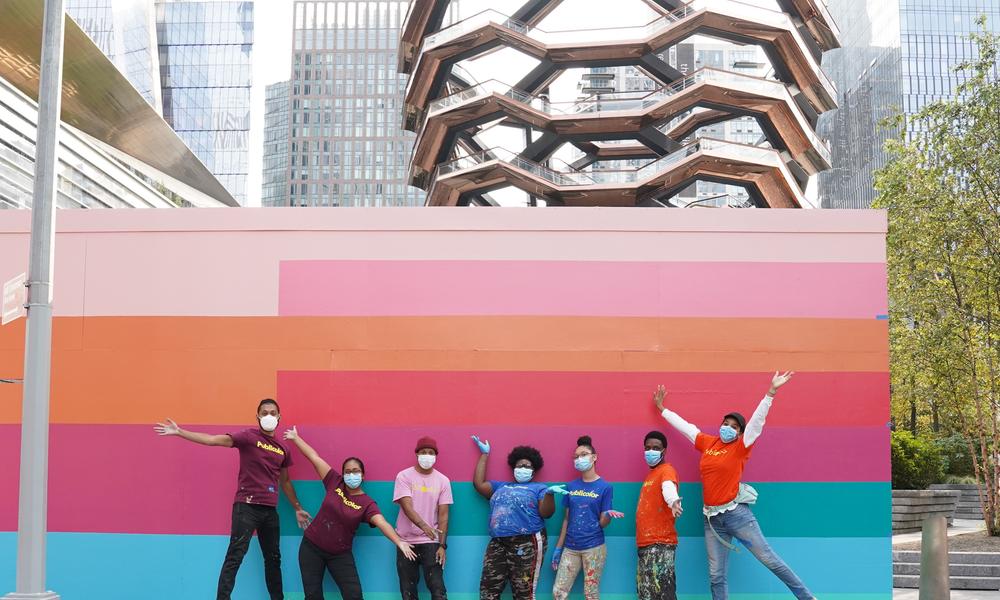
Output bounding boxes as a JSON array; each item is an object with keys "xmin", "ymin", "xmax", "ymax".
[{"xmin": 653, "ymin": 371, "xmax": 815, "ymax": 600}]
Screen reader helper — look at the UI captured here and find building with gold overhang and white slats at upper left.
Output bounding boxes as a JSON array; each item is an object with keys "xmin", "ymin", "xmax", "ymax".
[{"xmin": 0, "ymin": 0, "xmax": 237, "ymax": 209}]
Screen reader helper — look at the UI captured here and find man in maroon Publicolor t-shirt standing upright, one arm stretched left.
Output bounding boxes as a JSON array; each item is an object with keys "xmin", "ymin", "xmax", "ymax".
[{"xmin": 153, "ymin": 398, "xmax": 311, "ymax": 600}]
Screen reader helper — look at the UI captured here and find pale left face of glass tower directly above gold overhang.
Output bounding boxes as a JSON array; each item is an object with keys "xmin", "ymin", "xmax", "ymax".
[{"xmin": 65, "ymin": 0, "xmax": 163, "ymax": 112}]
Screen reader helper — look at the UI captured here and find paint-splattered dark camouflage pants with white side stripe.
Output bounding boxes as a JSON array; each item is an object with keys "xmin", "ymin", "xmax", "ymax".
[{"xmin": 479, "ymin": 530, "xmax": 548, "ymax": 600}]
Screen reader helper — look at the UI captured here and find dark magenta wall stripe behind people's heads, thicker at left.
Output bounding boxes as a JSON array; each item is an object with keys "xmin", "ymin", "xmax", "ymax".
[{"xmin": 0, "ymin": 424, "xmax": 889, "ymax": 534}]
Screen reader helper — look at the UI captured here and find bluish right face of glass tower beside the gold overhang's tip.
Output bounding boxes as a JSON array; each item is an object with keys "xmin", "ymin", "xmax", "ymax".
[{"xmin": 156, "ymin": 0, "xmax": 253, "ymax": 204}]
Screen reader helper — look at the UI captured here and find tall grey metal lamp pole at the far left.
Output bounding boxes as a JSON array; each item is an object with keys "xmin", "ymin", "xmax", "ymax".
[{"xmin": 6, "ymin": 0, "xmax": 65, "ymax": 600}]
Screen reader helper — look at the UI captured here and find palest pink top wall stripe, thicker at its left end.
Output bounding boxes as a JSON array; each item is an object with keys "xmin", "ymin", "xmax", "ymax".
[{"xmin": 0, "ymin": 209, "xmax": 885, "ymax": 316}]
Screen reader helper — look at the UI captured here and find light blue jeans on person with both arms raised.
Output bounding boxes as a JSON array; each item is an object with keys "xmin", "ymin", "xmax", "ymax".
[{"xmin": 705, "ymin": 504, "xmax": 813, "ymax": 600}]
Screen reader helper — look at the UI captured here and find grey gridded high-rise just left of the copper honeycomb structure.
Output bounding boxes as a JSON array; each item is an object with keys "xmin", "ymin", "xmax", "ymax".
[{"xmin": 274, "ymin": 0, "xmax": 424, "ymax": 206}]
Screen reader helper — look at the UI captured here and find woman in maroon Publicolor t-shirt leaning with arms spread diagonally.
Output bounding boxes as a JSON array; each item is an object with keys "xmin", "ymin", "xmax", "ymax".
[{"xmin": 285, "ymin": 427, "xmax": 417, "ymax": 600}]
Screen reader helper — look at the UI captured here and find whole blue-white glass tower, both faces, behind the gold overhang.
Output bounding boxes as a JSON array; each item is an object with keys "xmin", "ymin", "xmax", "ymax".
[{"xmin": 66, "ymin": 0, "xmax": 253, "ymax": 204}]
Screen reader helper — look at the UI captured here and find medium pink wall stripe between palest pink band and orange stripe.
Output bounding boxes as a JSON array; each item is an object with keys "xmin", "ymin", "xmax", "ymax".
[{"xmin": 278, "ymin": 260, "xmax": 887, "ymax": 319}]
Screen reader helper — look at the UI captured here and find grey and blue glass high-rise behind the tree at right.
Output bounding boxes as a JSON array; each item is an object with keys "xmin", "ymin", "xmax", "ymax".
[{"xmin": 820, "ymin": 0, "xmax": 1000, "ymax": 208}]
